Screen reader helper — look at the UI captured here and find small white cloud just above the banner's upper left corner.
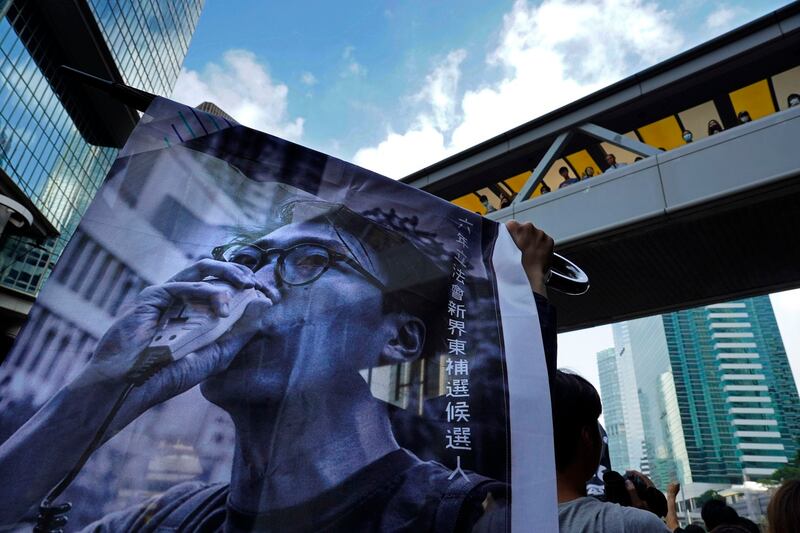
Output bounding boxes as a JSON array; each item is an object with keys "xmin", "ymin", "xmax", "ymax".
[{"xmin": 172, "ymin": 50, "xmax": 304, "ymax": 140}]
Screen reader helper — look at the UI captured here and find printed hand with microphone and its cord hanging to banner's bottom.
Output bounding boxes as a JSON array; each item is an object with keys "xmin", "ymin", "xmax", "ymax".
[{"xmin": 29, "ymin": 259, "xmax": 279, "ymax": 531}]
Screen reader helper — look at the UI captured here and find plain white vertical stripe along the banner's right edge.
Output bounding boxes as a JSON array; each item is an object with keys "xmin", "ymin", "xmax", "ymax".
[{"xmin": 492, "ymin": 224, "xmax": 558, "ymax": 533}]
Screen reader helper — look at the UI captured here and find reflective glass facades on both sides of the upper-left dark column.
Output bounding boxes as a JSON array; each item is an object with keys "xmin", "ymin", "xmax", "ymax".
[{"xmin": 0, "ymin": 0, "xmax": 203, "ymax": 295}]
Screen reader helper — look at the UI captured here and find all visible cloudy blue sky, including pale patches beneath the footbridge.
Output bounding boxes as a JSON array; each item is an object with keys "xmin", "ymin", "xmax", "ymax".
[{"xmin": 172, "ymin": 0, "xmax": 800, "ymax": 390}]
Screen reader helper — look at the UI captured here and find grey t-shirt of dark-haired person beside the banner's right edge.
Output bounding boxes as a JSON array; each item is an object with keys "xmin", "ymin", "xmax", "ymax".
[{"xmin": 558, "ymin": 497, "xmax": 671, "ymax": 533}]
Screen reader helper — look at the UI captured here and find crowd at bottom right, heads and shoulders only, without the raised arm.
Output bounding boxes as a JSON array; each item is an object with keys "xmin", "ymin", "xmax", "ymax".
[{"xmin": 551, "ymin": 364, "xmax": 800, "ymax": 533}]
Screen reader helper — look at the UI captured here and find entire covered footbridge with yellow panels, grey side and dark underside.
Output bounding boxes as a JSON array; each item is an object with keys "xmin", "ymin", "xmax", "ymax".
[{"xmin": 403, "ymin": 4, "xmax": 800, "ymax": 331}]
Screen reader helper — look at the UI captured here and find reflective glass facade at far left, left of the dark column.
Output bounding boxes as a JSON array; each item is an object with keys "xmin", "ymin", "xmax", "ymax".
[{"xmin": 0, "ymin": 14, "xmax": 116, "ymax": 294}]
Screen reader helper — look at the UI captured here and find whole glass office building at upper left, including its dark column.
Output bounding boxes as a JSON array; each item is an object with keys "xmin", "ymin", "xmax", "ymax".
[{"xmin": 0, "ymin": 0, "xmax": 203, "ymax": 336}]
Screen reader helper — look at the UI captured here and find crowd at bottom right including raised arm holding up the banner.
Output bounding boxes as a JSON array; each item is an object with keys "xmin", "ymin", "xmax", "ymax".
[{"xmin": 508, "ymin": 222, "xmax": 800, "ymax": 533}]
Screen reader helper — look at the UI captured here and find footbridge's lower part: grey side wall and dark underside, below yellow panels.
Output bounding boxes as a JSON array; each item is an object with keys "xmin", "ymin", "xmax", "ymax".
[{"xmin": 489, "ymin": 107, "xmax": 800, "ymax": 329}]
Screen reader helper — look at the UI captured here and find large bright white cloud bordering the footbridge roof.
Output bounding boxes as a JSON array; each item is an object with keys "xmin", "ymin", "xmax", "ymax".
[{"xmin": 354, "ymin": 0, "xmax": 683, "ymax": 178}]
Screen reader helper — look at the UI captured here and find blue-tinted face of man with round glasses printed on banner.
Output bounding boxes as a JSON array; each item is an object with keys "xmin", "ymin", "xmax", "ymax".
[{"xmin": 202, "ymin": 222, "xmax": 424, "ymax": 407}]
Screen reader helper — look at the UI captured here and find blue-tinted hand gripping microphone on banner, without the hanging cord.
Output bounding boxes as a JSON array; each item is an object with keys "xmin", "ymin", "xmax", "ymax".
[{"xmin": 89, "ymin": 259, "xmax": 280, "ymax": 403}]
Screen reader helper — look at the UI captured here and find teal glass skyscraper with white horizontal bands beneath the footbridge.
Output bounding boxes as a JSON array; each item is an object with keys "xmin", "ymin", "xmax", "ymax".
[{"xmin": 625, "ymin": 290, "xmax": 800, "ymax": 497}]
